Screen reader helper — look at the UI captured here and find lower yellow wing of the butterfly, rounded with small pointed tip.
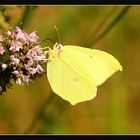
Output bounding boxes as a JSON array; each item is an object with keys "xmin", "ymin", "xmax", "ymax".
[{"xmin": 47, "ymin": 58, "xmax": 97, "ymax": 105}]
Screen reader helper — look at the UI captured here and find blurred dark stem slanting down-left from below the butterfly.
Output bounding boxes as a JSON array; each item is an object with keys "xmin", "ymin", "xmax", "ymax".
[{"xmin": 24, "ymin": 93, "xmax": 54, "ymax": 134}]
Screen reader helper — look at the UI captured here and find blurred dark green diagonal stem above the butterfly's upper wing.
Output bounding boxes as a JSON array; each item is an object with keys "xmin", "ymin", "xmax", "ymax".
[{"xmin": 89, "ymin": 6, "xmax": 131, "ymax": 46}]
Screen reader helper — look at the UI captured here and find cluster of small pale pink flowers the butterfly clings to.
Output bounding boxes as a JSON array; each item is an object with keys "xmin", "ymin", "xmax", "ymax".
[{"xmin": 0, "ymin": 27, "xmax": 46, "ymax": 94}]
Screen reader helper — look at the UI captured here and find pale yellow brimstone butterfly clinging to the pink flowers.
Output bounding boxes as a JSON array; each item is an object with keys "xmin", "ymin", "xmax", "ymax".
[{"xmin": 47, "ymin": 25, "xmax": 122, "ymax": 105}]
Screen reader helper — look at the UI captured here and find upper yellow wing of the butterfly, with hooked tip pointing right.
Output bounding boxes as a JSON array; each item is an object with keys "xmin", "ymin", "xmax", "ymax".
[{"xmin": 60, "ymin": 45, "xmax": 122, "ymax": 85}]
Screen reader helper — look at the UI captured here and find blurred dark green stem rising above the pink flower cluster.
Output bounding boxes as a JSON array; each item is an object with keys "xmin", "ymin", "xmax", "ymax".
[{"xmin": 17, "ymin": 6, "xmax": 37, "ymax": 29}]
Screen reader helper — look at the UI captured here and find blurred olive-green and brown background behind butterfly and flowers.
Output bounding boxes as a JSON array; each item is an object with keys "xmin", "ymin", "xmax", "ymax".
[{"xmin": 0, "ymin": 5, "xmax": 140, "ymax": 134}]
